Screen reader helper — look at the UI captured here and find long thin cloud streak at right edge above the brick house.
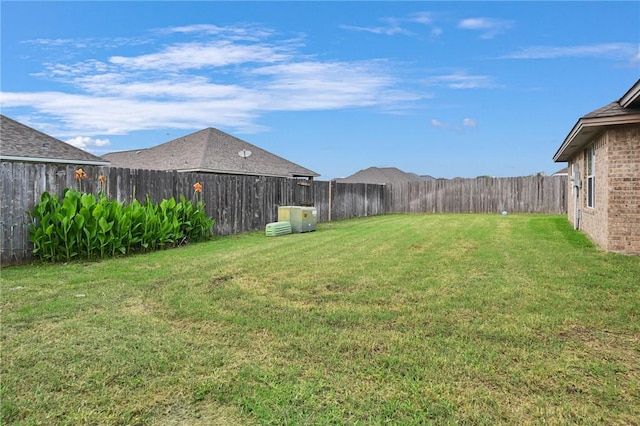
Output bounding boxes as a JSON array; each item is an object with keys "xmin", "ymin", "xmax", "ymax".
[{"xmin": 502, "ymin": 43, "xmax": 640, "ymax": 60}]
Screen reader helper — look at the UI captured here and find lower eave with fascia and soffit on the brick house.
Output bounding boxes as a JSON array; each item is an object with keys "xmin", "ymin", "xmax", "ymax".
[{"xmin": 553, "ymin": 112, "xmax": 640, "ymax": 163}]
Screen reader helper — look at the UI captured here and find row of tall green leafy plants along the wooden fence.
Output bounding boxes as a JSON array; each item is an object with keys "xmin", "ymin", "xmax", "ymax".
[{"xmin": 29, "ymin": 189, "xmax": 215, "ymax": 262}]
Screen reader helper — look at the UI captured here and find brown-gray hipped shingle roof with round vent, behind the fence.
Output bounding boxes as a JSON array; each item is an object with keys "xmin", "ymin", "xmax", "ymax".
[{"xmin": 102, "ymin": 127, "xmax": 319, "ymax": 177}]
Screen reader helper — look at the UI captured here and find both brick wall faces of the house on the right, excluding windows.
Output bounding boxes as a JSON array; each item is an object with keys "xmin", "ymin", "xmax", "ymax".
[{"xmin": 568, "ymin": 125, "xmax": 640, "ymax": 254}]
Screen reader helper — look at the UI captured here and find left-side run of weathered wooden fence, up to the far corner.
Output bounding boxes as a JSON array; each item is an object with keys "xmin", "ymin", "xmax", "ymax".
[{"xmin": 0, "ymin": 162, "xmax": 384, "ymax": 264}]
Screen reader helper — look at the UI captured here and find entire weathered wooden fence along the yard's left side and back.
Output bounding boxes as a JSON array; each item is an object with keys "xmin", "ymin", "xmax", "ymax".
[{"xmin": 0, "ymin": 162, "xmax": 567, "ymax": 264}]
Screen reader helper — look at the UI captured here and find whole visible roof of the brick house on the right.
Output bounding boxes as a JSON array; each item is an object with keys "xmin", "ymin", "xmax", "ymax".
[{"xmin": 553, "ymin": 80, "xmax": 640, "ymax": 162}]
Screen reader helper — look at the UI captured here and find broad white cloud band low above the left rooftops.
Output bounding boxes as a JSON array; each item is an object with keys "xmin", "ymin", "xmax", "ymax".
[{"xmin": 2, "ymin": 56, "xmax": 421, "ymax": 136}]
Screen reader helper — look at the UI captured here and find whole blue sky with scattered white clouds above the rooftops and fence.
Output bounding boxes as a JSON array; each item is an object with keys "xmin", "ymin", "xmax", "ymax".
[{"xmin": 0, "ymin": 1, "xmax": 640, "ymax": 180}]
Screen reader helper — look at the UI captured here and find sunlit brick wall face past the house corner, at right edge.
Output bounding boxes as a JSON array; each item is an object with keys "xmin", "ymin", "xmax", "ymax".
[{"xmin": 607, "ymin": 124, "xmax": 640, "ymax": 254}]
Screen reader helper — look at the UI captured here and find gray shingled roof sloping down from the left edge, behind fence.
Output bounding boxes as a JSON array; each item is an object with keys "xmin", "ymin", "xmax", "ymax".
[{"xmin": 0, "ymin": 115, "xmax": 109, "ymax": 166}]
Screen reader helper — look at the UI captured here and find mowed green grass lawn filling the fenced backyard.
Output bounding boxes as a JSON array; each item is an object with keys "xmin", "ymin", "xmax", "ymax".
[{"xmin": 0, "ymin": 214, "xmax": 640, "ymax": 425}]
